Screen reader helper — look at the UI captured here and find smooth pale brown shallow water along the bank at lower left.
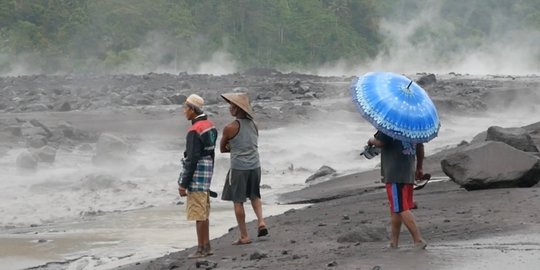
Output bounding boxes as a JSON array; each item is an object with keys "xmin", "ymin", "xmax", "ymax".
[{"xmin": 0, "ymin": 201, "xmax": 303, "ymax": 269}]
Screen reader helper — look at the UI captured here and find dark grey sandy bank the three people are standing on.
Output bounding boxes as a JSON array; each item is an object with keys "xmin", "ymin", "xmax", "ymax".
[{"xmin": 117, "ymin": 176, "xmax": 540, "ymax": 269}]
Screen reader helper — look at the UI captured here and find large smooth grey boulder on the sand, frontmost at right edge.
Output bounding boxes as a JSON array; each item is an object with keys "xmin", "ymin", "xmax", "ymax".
[{"xmin": 441, "ymin": 141, "xmax": 540, "ymax": 190}]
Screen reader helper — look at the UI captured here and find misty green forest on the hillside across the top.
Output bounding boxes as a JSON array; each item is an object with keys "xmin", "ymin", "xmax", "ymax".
[{"xmin": 0, "ymin": 0, "xmax": 540, "ymax": 74}]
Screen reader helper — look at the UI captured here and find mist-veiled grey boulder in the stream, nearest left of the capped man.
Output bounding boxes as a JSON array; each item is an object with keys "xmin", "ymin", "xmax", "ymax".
[{"xmin": 92, "ymin": 133, "xmax": 130, "ymax": 166}]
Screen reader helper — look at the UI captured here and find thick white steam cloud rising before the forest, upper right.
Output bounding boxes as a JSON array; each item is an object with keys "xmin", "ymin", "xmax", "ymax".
[{"xmin": 369, "ymin": 1, "xmax": 540, "ymax": 75}]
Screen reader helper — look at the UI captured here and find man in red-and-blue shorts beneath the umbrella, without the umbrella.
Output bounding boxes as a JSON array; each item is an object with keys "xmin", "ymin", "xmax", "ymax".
[{"xmin": 367, "ymin": 131, "xmax": 427, "ymax": 249}]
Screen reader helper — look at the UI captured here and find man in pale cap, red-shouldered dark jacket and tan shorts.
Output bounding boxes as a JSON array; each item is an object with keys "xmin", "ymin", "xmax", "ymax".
[{"xmin": 178, "ymin": 94, "xmax": 217, "ymax": 258}]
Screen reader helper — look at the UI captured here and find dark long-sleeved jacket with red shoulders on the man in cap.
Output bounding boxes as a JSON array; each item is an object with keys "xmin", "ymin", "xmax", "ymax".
[{"xmin": 178, "ymin": 114, "xmax": 218, "ymax": 188}]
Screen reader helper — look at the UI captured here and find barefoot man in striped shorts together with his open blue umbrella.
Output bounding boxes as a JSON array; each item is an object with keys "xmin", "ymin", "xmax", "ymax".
[{"xmin": 351, "ymin": 72, "xmax": 440, "ymax": 249}]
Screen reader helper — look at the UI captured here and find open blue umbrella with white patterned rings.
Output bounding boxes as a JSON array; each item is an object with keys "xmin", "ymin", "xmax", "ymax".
[{"xmin": 351, "ymin": 72, "xmax": 440, "ymax": 143}]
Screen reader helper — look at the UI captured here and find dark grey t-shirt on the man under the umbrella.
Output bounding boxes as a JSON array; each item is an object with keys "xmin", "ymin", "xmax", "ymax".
[{"xmin": 375, "ymin": 131, "xmax": 416, "ymax": 184}]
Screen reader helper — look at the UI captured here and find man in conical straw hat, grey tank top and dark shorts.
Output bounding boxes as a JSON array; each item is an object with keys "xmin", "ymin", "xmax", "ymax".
[{"xmin": 220, "ymin": 93, "xmax": 268, "ymax": 245}]
